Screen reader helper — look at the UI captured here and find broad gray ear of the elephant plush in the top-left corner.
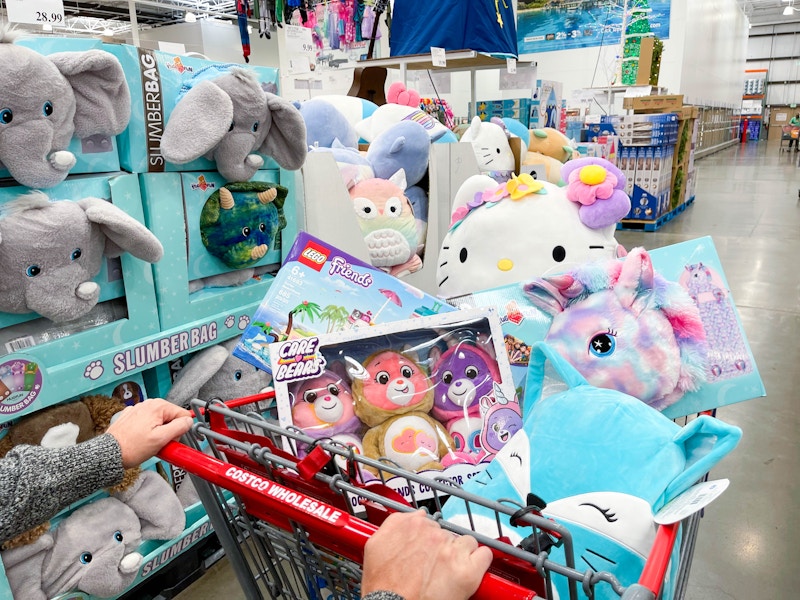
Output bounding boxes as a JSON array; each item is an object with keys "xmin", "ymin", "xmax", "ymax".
[{"xmin": 48, "ymin": 50, "xmax": 131, "ymax": 138}]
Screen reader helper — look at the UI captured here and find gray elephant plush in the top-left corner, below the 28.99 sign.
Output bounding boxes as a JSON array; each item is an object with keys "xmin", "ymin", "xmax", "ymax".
[{"xmin": 0, "ymin": 33, "xmax": 131, "ymax": 188}]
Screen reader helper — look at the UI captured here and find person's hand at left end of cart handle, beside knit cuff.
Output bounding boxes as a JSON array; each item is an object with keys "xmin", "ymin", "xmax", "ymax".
[{"xmin": 107, "ymin": 398, "xmax": 192, "ymax": 469}]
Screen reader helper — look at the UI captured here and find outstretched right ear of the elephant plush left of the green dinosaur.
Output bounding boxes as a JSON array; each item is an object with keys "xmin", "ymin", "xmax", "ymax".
[{"xmin": 78, "ymin": 198, "xmax": 164, "ymax": 263}]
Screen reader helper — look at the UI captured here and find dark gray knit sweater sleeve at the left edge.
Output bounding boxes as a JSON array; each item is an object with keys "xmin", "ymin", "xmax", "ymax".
[{"xmin": 0, "ymin": 433, "xmax": 124, "ymax": 543}]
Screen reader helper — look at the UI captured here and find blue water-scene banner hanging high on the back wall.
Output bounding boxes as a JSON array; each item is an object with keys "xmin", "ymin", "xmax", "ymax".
[{"xmin": 517, "ymin": 0, "xmax": 670, "ymax": 54}]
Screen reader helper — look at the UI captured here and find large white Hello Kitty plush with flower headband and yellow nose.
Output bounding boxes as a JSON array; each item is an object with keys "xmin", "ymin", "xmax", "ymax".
[{"xmin": 436, "ymin": 158, "xmax": 630, "ymax": 298}]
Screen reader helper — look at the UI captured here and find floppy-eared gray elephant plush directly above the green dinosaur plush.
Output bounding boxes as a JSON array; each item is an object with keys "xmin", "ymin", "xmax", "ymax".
[{"xmin": 161, "ymin": 68, "xmax": 307, "ymax": 182}]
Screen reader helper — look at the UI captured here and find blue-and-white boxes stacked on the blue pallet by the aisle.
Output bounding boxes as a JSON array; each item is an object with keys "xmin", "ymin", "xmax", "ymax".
[{"xmin": 589, "ymin": 113, "xmax": 678, "ymax": 221}]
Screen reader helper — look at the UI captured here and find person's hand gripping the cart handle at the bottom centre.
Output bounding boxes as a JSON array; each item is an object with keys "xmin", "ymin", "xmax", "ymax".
[{"xmin": 361, "ymin": 510, "xmax": 492, "ymax": 600}]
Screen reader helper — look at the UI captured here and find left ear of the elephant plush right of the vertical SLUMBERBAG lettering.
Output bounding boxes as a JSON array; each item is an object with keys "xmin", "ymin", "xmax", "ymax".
[{"xmin": 161, "ymin": 81, "xmax": 233, "ymax": 165}]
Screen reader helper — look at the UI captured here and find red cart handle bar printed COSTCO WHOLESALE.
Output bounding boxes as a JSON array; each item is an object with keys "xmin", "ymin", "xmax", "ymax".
[{"xmin": 158, "ymin": 442, "xmax": 538, "ymax": 600}]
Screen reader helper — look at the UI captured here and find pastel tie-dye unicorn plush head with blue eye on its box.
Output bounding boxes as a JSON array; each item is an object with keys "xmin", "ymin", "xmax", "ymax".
[{"xmin": 524, "ymin": 248, "xmax": 707, "ymax": 410}]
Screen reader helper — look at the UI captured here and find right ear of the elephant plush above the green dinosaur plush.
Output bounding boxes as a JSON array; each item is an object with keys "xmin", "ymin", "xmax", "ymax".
[{"xmin": 259, "ymin": 92, "xmax": 308, "ymax": 171}]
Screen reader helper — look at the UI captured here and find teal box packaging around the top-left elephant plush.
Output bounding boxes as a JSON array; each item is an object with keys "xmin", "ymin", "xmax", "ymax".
[{"xmin": 0, "ymin": 37, "xmax": 120, "ymax": 178}]
